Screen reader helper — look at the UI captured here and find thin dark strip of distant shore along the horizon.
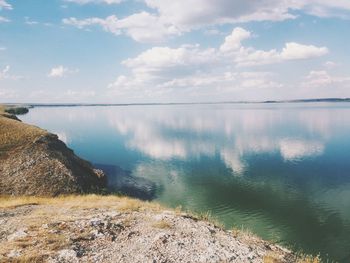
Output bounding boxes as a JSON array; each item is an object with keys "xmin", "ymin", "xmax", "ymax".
[{"xmin": 2, "ymin": 98, "xmax": 350, "ymax": 108}]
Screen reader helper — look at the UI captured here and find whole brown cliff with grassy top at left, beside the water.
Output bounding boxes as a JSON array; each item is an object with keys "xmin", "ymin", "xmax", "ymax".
[{"xmin": 0, "ymin": 108, "xmax": 106, "ymax": 196}]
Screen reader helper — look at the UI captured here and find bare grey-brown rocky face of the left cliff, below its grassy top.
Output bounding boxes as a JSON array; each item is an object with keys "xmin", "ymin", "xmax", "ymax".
[{"xmin": 0, "ymin": 133, "xmax": 107, "ymax": 196}]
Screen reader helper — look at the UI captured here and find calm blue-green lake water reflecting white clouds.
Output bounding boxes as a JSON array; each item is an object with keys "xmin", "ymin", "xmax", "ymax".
[{"xmin": 22, "ymin": 103, "xmax": 350, "ymax": 262}]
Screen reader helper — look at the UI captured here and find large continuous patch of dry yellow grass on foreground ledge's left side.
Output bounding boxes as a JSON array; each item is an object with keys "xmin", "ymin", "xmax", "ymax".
[{"xmin": 0, "ymin": 195, "xmax": 161, "ymax": 262}]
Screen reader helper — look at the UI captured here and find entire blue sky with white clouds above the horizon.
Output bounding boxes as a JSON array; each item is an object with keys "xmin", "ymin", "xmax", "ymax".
[{"xmin": 0, "ymin": 0, "xmax": 350, "ymax": 103}]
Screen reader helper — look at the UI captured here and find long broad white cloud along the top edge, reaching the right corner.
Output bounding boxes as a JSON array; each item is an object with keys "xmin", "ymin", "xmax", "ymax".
[{"xmin": 63, "ymin": 0, "xmax": 350, "ymax": 42}]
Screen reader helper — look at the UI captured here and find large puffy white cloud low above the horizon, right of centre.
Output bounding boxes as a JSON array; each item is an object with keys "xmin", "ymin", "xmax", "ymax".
[{"xmin": 109, "ymin": 27, "xmax": 328, "ymax": 100}]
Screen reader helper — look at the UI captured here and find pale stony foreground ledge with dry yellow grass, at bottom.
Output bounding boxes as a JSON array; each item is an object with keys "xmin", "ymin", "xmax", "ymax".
[{"xmin": 0, "ymin": 196, "xmax": 296, "ymax": 262}]
